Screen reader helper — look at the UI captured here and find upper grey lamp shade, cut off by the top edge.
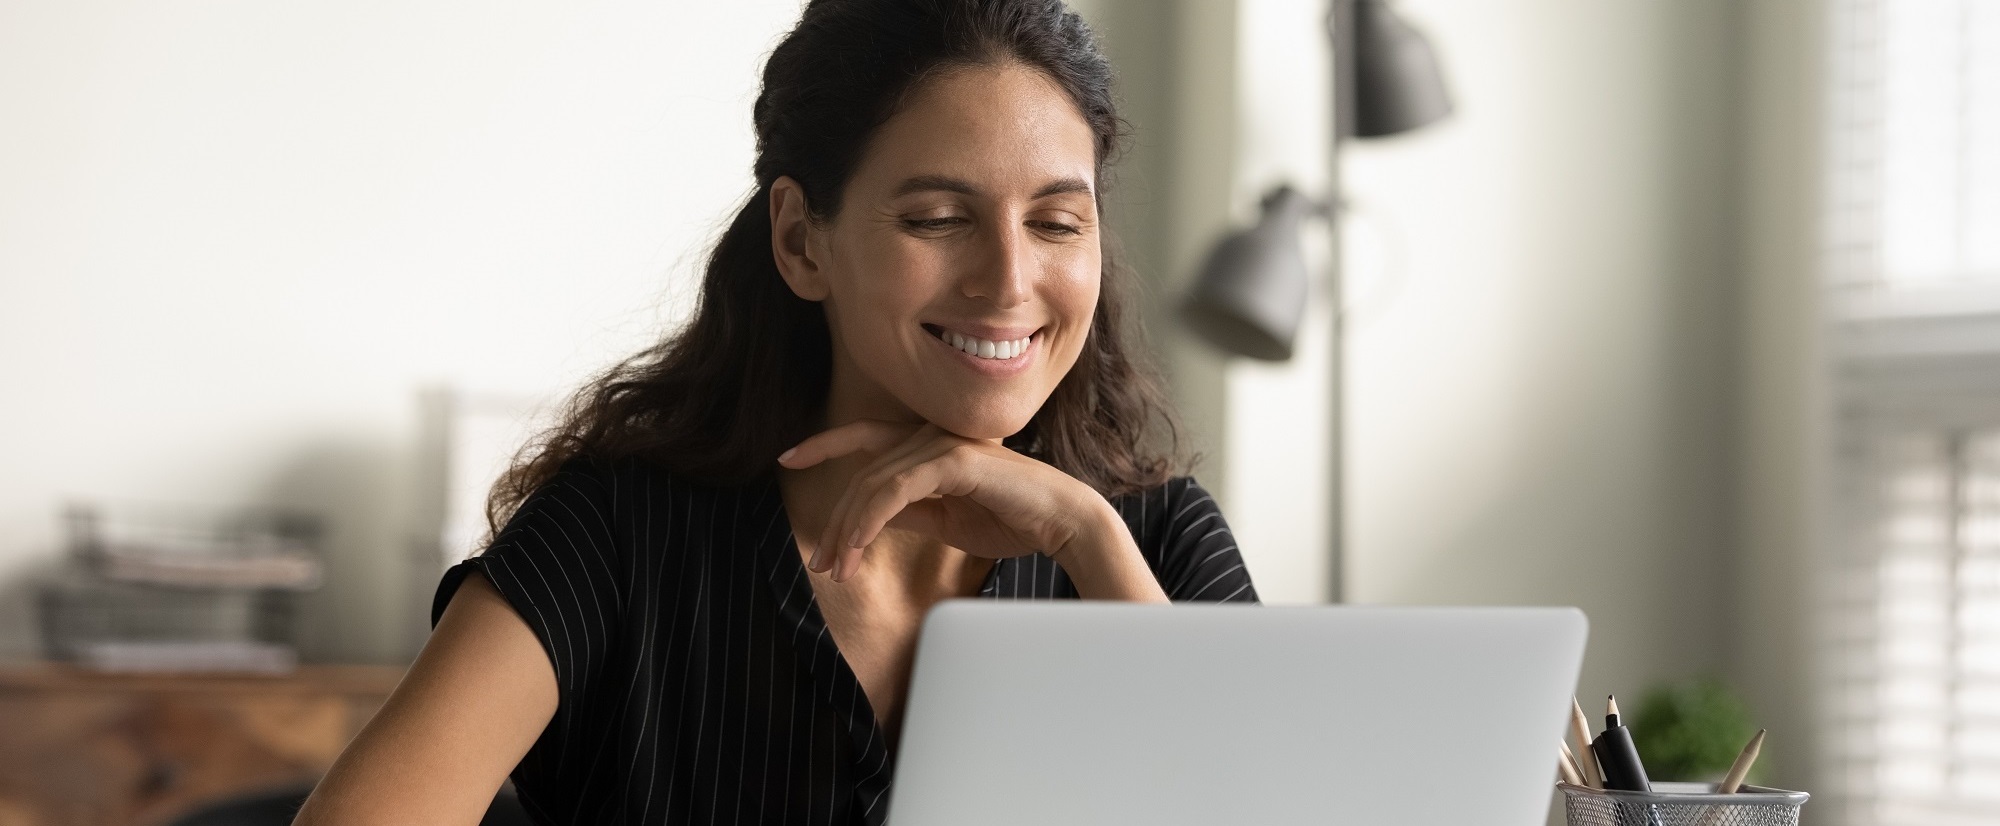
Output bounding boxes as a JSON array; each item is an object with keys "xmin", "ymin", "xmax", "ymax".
[{"xmin": 1350, "ymin": 0, "xmax": 1452, "ymax": 138}]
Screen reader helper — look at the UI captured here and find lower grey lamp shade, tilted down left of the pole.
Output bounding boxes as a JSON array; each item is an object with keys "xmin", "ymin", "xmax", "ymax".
[{"xmin": 1180, "ymin": 186, "xmax": 1316, "ymax": 362}]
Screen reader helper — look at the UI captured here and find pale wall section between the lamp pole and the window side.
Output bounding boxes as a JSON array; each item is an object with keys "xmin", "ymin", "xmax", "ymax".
[{"xmin": 1344, "ymin": 0, "xmax": 1738, "ymax": 708}]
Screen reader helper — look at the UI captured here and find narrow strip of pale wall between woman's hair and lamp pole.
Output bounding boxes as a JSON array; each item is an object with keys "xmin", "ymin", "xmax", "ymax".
[{"xmin": 1072, "ymin": 0, "xmax": 1332, "ymax": 602}]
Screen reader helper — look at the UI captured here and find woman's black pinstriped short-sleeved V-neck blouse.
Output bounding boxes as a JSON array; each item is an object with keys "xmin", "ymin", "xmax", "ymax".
[{"xmin": 432, "ymin": 460, "xmax": 1256, "ymax": 826}]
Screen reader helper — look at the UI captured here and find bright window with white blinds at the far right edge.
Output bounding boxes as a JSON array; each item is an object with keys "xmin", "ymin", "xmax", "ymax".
[{"xmin": 1818, "ymin": 0, "xmax": 2000, "ymax": 826}]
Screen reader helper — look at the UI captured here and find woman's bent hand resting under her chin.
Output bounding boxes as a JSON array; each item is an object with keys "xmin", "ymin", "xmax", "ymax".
[{"xmin": 778, "ymin": 420, "xmax": 1136, "ymax": 582}]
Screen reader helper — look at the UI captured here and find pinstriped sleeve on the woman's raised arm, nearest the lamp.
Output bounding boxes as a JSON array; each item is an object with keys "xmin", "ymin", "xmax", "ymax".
[{"xmin": 1118, "ymin": 476, "xmax": 1258, "ymax": 602}]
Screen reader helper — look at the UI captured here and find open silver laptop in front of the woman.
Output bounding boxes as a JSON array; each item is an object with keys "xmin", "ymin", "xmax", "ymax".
[{"xmin": 888, "ymin": 600, "xmax": 1586, "ymax": 826}]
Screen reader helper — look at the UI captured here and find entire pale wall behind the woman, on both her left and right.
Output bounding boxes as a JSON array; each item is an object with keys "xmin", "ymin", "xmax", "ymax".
[{"xmin": 0, "ymin": 0, "xmax": 1776, "ymax": 728}]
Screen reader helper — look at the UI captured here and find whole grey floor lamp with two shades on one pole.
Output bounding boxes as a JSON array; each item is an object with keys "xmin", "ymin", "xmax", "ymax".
[{"xmin": 1180, "ymin": 0, "xmax": 1452, "ymax": 602}]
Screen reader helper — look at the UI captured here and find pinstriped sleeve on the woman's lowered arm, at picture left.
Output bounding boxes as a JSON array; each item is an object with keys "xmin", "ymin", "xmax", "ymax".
[{"xmin": 430, "ymin": 460, "xmax": 624, "ymax": 706}]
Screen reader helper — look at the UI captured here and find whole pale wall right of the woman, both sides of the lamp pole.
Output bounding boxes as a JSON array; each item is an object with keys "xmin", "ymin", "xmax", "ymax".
[{"xmin": 1128, "ymin": 0, "xmax": 1824, "ymax": 788}]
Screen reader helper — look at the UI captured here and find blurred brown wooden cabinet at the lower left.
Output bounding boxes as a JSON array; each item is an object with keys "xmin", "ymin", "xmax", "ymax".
[{"xmin": 0, "ymin": 664, "xmax": 402, "ymax": 826}]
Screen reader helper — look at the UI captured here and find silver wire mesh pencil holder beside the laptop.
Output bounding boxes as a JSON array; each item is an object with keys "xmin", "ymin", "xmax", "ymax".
[{"xmin": 1556, "ymin": 782, "xmax": 1810, "ymax": 826}]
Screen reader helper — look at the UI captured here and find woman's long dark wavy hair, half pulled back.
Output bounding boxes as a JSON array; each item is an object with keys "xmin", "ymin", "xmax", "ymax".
[{"xmin": 486, "ymin": 0, "xmax": 1188, "ymax": 528}]
